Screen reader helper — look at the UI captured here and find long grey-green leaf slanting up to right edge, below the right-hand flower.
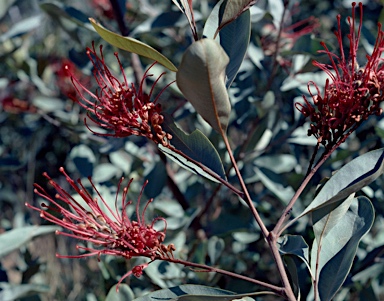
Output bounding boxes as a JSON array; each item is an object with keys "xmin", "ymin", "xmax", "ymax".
[{"xmin": 295, "ymin": 148, "xmax": 384, "ymax": 220}]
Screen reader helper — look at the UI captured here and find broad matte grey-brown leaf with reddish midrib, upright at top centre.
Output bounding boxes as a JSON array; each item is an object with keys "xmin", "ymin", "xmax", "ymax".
[{"xmin": 176, "ymin": 39, "xmax": 231, "ymax": 136}]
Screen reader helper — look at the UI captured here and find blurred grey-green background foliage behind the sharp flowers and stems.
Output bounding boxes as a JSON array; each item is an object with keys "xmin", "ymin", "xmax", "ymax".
[{"xmin": 0, "ymin": 0, "xmax": 384, "ymax": 301}]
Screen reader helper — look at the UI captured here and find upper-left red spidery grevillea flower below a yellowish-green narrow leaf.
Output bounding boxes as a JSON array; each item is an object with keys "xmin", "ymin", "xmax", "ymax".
[{"xmin": 66, "ymin": 44, "xmax": 172, "ymax": 146}]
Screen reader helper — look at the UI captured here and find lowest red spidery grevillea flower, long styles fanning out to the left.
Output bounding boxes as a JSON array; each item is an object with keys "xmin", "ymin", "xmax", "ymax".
[{"xmin": 25, "ymin": 168, "xmax": 175, "ymax": 283}]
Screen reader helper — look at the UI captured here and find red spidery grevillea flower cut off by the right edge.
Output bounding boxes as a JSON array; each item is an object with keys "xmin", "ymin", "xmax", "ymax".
[{"xmin": 295, "ymin": 2, "xmax": 384, "ymax": 149}]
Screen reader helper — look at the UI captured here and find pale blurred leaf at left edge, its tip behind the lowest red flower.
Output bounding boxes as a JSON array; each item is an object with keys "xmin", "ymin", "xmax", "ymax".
[{"xmin": 0, "ymin": 226, "xmax": 60, "ymax": 258}]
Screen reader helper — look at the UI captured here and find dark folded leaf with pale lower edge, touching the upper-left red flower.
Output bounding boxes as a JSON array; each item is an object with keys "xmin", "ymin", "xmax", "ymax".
[{"xmin": 159, "ymin": 116, "xmax": 226, "ymax": 182}]
